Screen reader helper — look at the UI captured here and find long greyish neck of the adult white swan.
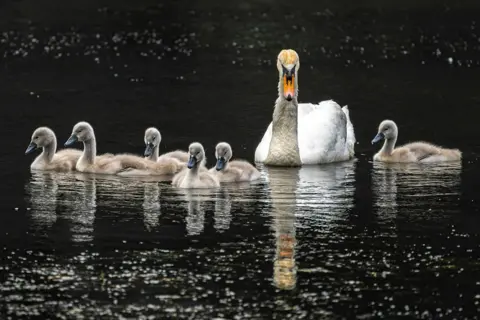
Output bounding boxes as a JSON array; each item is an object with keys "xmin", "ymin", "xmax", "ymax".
[{"xmin": 265, "ymin": 94, "xmax": 302, "ymax": 167}]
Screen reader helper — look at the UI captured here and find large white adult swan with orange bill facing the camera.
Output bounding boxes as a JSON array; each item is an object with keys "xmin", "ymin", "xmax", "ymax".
[{"xmin": 255, "ymin": 49, "xmax": 355, "ymax": 167}]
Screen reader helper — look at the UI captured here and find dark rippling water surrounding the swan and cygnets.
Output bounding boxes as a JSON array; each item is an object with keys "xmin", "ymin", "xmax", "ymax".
[{"xmin": 0, "ymin": 1, "xmax": 480, "ymax": 319}]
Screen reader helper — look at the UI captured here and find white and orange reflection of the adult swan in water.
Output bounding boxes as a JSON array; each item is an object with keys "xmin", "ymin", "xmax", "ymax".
[{"xmin": 266, "ymin": 161, "xmax": 355, "ymax": 290}]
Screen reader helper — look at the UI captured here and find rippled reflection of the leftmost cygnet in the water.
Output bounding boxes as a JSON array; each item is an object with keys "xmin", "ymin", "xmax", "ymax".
[{"xmin": 25, "ymin": 171, "xmax": 58, "ymax": 232}]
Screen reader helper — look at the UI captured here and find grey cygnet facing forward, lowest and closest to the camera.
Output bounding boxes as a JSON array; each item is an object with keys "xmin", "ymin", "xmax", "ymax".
[{"xmin": 172, "ymin": 142, "xmax": 220, "ymax": 189}]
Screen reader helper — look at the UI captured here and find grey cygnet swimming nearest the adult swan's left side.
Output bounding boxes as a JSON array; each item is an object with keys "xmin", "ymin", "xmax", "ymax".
[{"xmin": 210, "ymin": 142, "xmax": 260, "ymax": 182}]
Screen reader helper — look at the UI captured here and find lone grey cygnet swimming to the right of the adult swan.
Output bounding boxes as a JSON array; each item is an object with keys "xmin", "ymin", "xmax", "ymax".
[{"xmin": 372, "ymin": 120, "xmax": 462, "ymax": 162}]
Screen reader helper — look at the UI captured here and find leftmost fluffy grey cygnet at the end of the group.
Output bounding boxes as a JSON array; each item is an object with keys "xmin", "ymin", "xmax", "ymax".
[{"xmin": 25, "ymin": 127, "xmax": 82, "ymax": 171}]
